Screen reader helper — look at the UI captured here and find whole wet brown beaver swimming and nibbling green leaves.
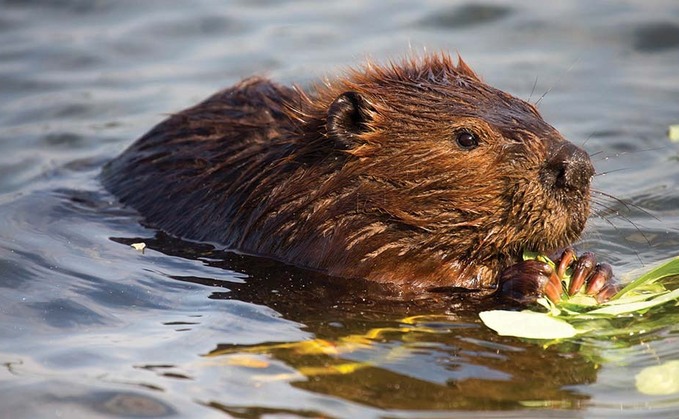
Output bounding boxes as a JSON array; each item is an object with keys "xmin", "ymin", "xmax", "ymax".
[{"xmin": 101, "ymin": 53, "xmax": 614, "ymax": 306}]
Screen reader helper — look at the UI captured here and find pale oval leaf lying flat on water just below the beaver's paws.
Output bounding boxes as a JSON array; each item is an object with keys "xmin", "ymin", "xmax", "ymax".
[{"xmin": 479, "ymin": 310, "xmax": 578, "ymax": 339}]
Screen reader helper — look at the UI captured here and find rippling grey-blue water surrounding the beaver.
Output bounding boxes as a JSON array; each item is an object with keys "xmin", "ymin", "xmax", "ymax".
[{"xmin": 0, "ymin": 0, "xmax": 679, "ymax": 418}]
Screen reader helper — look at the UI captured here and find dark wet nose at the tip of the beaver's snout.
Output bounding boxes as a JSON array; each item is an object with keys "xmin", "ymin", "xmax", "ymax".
[{"xmin": 543, "ymin": 141, "xmax": 594, "ymax": 190}]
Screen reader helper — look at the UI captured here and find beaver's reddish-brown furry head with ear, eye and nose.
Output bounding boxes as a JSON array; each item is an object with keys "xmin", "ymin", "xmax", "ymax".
[{"xmin": 278, "ymin": 56, "xmax": 594, "ymax": 287}]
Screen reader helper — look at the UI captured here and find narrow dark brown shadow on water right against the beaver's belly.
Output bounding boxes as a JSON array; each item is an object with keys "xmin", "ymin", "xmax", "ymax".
[{"xmin": 111, "ymin": 232, "xmax": 496, "ymax": 324}]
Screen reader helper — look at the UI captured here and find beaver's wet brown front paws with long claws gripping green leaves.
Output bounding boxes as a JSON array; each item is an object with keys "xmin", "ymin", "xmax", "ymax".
[{"xmin": 499, "ymin": 247, "xmax": 620, "ymax": 304}]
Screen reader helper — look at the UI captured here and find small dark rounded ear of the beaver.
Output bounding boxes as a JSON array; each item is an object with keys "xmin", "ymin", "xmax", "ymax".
[{"xmin": 325, "ymin": 92, "xmax": 370, "ymax": 150}]
